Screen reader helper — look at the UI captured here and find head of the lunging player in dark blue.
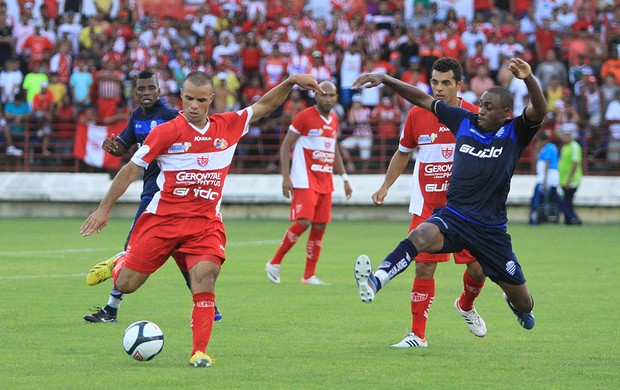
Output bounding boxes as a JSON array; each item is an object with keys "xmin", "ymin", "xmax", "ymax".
[{"xmin": 478, "ymin": 87, "xmax": 514, "ymax": 131}]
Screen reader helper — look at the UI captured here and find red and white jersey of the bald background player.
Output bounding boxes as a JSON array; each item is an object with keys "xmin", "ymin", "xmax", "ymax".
[{"xmin": 289, "ymin": 106, "xmax": 338, "ymax": 194}]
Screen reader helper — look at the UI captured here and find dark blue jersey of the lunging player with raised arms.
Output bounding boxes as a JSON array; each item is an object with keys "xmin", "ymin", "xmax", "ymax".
[{"xmin": 431, "ymin": 100, "xmax": 542, "ymax": 227}]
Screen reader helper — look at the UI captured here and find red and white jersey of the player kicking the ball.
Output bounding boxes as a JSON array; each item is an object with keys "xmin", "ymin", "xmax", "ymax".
[{"xmin": 131, "ymin": 107, "xmax": 253, "ymax": 220}]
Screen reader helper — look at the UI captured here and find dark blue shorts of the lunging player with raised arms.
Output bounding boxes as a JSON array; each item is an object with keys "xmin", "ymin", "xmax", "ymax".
[{"xmin": 426, "ymin": 208, "xmax": 525, "ymax": 285}]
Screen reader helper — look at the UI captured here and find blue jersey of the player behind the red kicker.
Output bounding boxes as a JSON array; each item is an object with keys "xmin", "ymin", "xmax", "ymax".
[{"xmin": 116, "ymin": 99, "xmax": 179, "ymax": 200}]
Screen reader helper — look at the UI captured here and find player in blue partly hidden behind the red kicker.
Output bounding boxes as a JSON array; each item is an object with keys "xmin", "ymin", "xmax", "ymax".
[{"xmin": 84, "ymin": 71, "xmax": 222, "ymax": 322}]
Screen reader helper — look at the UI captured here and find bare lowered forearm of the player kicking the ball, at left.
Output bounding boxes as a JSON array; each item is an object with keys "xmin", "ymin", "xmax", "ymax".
[{"xmin": 80, "ymin": 161, "xmax": 142, "ymax": 237}]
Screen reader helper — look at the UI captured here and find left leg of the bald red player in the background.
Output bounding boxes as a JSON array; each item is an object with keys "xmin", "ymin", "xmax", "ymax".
[{"xmin": 265, "ymin": 188, "xmax": 316, "ymax": 284}]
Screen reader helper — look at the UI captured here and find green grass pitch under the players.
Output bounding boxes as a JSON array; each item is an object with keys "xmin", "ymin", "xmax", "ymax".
[{"xmin": 0, "ymin": 219, "xmax": 620, "ymax": 389}]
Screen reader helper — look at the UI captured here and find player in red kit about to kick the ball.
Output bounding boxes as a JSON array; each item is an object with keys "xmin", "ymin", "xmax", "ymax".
[{"xmin": 80, "ymin": 72, "xmax": 324, "ymax": 367}]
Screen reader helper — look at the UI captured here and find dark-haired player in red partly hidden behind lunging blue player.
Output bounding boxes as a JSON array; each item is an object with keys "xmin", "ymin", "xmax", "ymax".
[{"xmin": 372, "ymin": 57, "xmax": 486, "ymax": 348}]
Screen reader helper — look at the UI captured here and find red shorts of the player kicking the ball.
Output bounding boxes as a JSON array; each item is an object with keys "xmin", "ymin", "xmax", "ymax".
[{"xmin": 125, "ymin": 213, "xmax": 226, "ymax": 274}]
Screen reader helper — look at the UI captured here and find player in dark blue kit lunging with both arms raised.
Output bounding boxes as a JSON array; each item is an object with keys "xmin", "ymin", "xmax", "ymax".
[{"xmin": 353, "ymin": 58, "xmax": 547, "ymax": 329}]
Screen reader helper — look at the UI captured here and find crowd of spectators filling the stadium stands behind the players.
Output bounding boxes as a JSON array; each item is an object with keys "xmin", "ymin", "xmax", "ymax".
[{"xmin": 0, "ymin": 0, "xmax": 620, "ymax": 171}]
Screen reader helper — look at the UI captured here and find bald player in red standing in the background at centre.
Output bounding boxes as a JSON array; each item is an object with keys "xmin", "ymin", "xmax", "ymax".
[{"xmin": 266, "ymin": 81, "xmax": 353, "ymax": 285}]
